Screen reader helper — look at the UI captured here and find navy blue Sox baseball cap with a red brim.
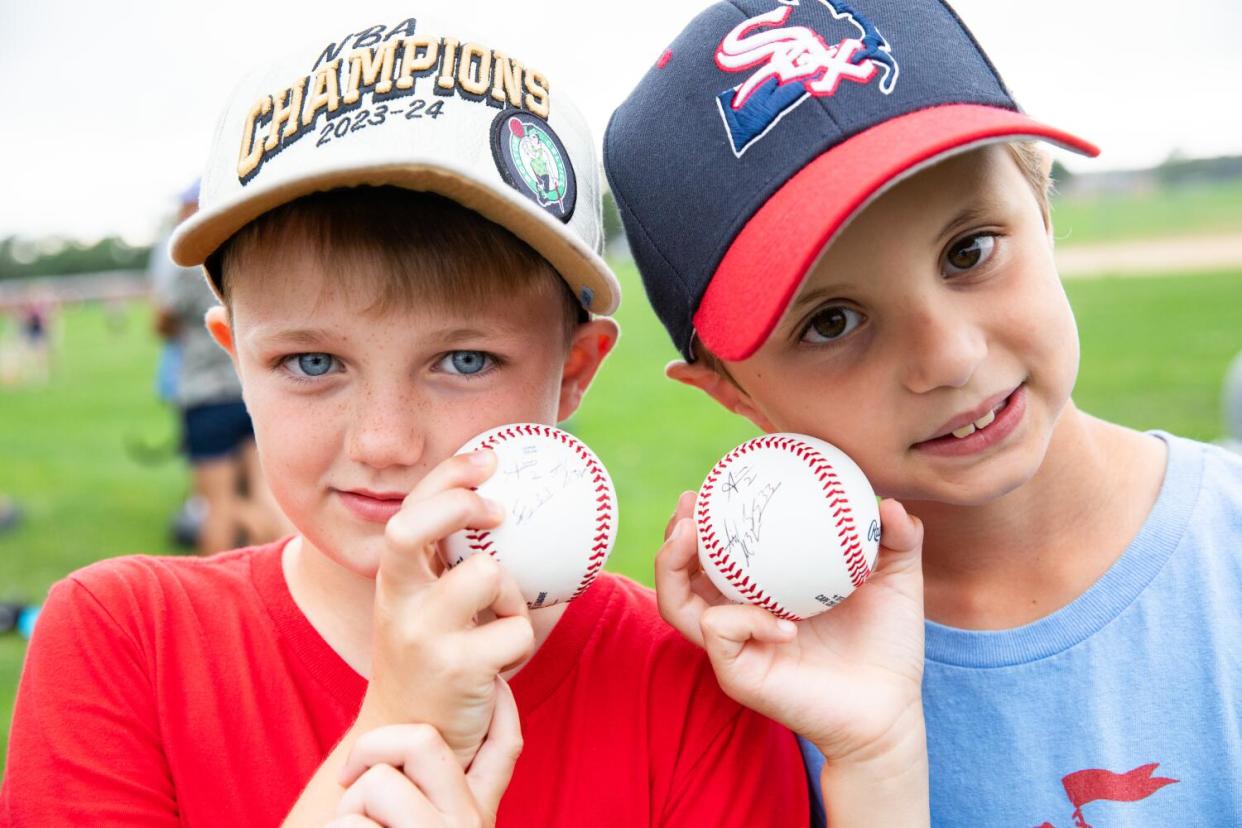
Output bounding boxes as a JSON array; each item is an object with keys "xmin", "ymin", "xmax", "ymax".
[{"xmin": 604, "ymin": 0, "xmax": 1099, "ymax": 361}]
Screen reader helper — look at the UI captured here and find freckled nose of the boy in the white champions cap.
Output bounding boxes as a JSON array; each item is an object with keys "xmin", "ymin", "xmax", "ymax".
[{"xmin": 348, "ymin": 384, "xmax": 425, "ymax": 469}]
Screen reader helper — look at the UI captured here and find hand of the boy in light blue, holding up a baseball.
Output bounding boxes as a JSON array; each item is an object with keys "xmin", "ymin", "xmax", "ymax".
[{"xmin": 656, "ymin": 492, "xmax": 925, "ymax": 804}]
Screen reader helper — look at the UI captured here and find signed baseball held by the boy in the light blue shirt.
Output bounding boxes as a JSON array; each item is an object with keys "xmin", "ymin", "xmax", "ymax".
[{"xmin": 694, "ymin": 433, "xmax": 879, "ymax": 621}]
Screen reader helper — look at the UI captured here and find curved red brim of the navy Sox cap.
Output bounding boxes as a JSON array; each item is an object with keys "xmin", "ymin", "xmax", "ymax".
[{"xmin": 694, "ymin": 104, "xmax": 1099, "ymax": 361}]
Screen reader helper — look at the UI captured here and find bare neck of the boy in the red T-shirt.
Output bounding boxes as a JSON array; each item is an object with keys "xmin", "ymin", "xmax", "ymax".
[{"xmin": 281, "ymin": 535, "xmax": 566, "ymax": 679}]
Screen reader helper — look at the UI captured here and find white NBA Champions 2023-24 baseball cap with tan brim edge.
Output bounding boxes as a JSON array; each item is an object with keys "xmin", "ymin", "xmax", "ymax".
[{"xmin": 171, "ymin": 12, "xmax": 621, "ymax": 314}]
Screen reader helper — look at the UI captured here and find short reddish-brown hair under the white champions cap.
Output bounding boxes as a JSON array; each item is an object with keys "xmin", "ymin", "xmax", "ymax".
[{"xmin": 207, "ymin": 186, "xmax": 589, "ymax": 343}]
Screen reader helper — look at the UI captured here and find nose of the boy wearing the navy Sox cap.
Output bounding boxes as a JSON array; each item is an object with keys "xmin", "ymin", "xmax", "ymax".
[{"xmin": 900, "ymin": 298, "xmax": 987, "ymax": 394}]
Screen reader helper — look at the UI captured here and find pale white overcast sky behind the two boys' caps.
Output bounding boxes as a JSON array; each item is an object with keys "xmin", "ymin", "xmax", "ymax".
[{"xmin": 0, "ymin": 0, "xmax": 1242, "ymax": 242}]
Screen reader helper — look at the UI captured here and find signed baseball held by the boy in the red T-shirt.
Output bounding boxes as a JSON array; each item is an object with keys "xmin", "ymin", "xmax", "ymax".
[{"xmin": 445, "ymin": 423, "xmax": 617, "ymax": 610}]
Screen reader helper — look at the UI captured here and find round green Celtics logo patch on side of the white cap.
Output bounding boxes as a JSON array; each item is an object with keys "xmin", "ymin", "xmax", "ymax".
[{"xmin": 492, "ymin": 109, "xmax": 578, "ymax": 221}]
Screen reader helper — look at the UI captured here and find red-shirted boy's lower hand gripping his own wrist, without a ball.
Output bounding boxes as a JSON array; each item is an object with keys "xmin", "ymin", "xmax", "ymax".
[{"xmin": 332, "ymin": 679, "xmax": 522, "ymax": 828}]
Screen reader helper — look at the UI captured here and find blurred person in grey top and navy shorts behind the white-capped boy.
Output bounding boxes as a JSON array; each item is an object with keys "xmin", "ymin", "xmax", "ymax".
[{"xmin": 148, "ymin": 184, "xmax": 289, "ymax": 555}]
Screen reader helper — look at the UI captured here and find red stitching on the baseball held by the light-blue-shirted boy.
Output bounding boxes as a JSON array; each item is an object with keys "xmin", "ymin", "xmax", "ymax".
[{"xmin": 696, "ymin": 434, "xmax": 871, "ymax": 621}]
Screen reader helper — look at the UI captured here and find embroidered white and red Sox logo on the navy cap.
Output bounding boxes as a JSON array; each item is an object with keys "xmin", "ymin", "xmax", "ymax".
[{"xmin": 715, "ymin": 0, "xmax": 899, "ymax": 158}]
